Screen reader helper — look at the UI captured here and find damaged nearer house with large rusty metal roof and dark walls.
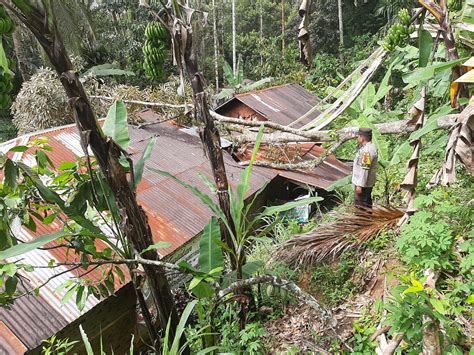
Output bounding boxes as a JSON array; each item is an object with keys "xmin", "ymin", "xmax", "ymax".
[{"xmin": 0, "ymin": 100, "xmax": 350, "ymax": 354}]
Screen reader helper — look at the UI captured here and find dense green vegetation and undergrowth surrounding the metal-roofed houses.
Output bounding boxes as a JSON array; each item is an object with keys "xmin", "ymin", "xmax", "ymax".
[{"xmin": 0, "ymin": 0, "xmax": 474, "ymax": 354}]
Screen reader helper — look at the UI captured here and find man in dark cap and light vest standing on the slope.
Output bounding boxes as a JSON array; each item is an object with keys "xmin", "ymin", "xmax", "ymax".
[{"xmin": 352, "ymin": 128, "xmax": 378, "ymax": 208}]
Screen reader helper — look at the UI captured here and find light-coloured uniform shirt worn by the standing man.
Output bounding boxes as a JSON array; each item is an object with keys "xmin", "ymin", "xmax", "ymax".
[{"xmin": 352, "ymin": 142, "xmax": 378, "ymax": 187}]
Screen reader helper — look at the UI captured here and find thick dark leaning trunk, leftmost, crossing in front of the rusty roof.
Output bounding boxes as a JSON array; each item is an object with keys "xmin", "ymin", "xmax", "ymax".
[{"xmin": 0, "ymin": 0, "xmax": 179, "ymax": 346}]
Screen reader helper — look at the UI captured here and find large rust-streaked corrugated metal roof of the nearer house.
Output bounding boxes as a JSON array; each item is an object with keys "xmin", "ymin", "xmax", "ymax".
[{"xmin": 0, "ymin": 112, "xmax": 349, "ymax": 348}]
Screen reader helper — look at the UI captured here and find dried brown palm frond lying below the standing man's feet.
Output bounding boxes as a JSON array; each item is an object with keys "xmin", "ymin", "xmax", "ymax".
[{"xmin": 277, "ymin": 206, "xmax": 403, "ymax": 267}]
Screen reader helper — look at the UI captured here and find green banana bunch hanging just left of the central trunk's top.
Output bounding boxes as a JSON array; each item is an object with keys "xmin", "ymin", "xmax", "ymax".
[{"xmin": 143, "ymin": 22, "xmax": 169, "ymax": 81}]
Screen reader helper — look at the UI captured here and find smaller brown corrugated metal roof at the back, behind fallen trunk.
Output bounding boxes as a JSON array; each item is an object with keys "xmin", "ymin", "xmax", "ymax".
[{"xmin": 216, "ymin": 84, "xmax": 321, "ymax": 128}]
